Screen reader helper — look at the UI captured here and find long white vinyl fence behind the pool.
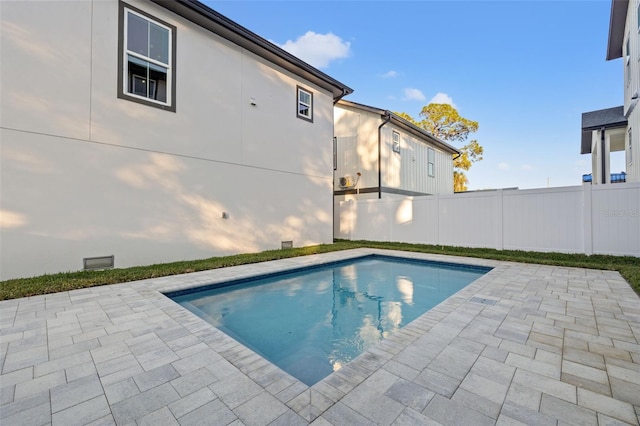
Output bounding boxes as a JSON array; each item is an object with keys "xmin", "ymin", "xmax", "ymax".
[{"xmin": 334, "ymin": 183, "xmax": 640, "ymax": 257}]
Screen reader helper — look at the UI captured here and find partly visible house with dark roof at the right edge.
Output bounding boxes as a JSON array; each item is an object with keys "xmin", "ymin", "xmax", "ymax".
[{"xmin": 580, "ymin": 0, "xmax": 640, "ymax": 184}]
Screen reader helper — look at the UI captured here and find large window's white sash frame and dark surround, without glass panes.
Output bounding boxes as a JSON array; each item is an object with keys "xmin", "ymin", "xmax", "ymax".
[{"xmin": 118, "ymin": 2, "xmax": 176, "ymax": 112}]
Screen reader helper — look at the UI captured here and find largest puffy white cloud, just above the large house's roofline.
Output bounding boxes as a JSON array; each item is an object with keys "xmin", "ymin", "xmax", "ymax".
[{"xmin": 276, "ymin": 31, "xmax": 351, "ymax": 68}]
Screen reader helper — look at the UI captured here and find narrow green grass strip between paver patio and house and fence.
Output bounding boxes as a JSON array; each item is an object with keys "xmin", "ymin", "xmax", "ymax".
[{"xmin": 0, "ymin": 241, "xmax": 640, "ymax": 300}]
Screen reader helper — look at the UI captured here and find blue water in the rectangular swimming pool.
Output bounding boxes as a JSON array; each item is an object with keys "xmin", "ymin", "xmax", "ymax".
[{"xmin": 168, "ymin": 255, "xmax": 491, "ymax": 386}]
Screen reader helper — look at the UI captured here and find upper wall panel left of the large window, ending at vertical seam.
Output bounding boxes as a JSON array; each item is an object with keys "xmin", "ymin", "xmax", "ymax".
[{"xmin": 0, "ymin": 1, "xmax": 92, "ymax": 138}]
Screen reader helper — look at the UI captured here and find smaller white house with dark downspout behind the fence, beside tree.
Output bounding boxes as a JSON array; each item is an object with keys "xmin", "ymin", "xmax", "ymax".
[{"xmin": 334, "ymin": 100, "xmax": 460, "ymax": 201}]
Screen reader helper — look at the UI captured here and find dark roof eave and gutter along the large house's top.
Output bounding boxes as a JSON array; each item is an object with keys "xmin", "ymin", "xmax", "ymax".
[{"xmin": 151, "ymin": 0, "xmax": 353, "ymax": 100}]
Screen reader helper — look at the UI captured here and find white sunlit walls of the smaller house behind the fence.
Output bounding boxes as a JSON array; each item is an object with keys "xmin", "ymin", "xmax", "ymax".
[{"xmin": 334, "ymin": 104, "xmax": 453, "ymax": 199}]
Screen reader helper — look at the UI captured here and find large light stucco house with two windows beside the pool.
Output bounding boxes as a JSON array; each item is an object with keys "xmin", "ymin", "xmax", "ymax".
[{"xmin": 0, "ymin": 0, "xmax": 352, "ymax": 279}]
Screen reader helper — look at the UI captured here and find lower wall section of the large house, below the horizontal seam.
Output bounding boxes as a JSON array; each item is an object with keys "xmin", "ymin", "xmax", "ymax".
[{"xmin": 0, "ymin": 130, "xmax": 332, "ymax": 279}]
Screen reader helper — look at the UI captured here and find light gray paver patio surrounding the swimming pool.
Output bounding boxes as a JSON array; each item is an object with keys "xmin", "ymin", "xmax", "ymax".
[{"xmin": 0, "ymin": 249, "xmax": 640, "ymax": 426}]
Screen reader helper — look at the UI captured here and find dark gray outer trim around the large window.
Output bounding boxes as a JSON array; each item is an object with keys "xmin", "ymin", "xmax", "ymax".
[{"xmin": 118, "ymin": 1, "xmax": 178, "ymax": 112}]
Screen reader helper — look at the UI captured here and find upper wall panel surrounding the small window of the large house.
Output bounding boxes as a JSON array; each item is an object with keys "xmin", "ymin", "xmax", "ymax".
[{"xmin": 236, "ymin": 52, "xmax": 333, "ymax": 176}]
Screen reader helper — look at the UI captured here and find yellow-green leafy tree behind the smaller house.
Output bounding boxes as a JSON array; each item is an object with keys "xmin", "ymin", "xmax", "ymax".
[{"xmin": 397, "ymin": 104, "xmax": 484, "ymax": 192}]
